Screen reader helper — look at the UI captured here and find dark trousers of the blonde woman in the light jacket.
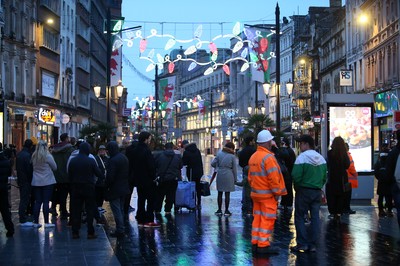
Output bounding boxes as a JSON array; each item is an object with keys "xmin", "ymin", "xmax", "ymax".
[{"xmin": 32, "ymin": 185, "xmax": 54, "ymax": 224}]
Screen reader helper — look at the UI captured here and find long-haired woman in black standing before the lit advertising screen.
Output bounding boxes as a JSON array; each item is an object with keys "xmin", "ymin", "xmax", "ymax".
[{"xmin": 326, "ymin": 137, "xmax": 350, "ymax": 222}]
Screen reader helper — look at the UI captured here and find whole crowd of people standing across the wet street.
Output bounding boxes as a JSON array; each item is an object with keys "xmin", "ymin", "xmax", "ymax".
[{"xmin": 0, "ymin": 130, "xmax": 400, "ymax": 254}]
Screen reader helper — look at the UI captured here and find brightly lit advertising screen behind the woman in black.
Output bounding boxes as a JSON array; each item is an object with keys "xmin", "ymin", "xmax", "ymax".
[{"xmin": 328, "ymin": 104, "xmax": 373, "ymax": 172}]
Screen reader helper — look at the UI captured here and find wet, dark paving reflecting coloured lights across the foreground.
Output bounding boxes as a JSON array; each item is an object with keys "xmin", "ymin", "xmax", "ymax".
[{"xmin": 0, "ymin": 155, "xmax": 400, "ymax": 265}]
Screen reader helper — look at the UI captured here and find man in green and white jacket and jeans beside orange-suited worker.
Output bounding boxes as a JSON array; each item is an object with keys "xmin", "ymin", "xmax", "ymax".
[{"xmin": 291, "ymin": 135, "xmax": 327, "ymax": 252}]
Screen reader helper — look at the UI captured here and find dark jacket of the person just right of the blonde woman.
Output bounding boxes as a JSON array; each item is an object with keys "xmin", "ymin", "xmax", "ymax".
[{"xmin": 51, "ymin": 142, "xmax": 75, "ymax": 183}]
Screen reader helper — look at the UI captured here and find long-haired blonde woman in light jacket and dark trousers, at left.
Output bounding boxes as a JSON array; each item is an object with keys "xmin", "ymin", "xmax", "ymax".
[{"xmin": 32, "ymin": 140, "xmax": 57, "ymax": 228}]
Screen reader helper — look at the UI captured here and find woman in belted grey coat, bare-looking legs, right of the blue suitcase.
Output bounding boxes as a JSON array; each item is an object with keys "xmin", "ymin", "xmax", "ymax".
[{"xmin": 211, "ymin": 142, "xmax": 237, "ymax": 216}]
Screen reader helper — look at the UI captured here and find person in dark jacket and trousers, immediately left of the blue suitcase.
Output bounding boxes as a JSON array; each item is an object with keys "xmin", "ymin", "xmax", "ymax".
[{"xmin": 155, "ymin": 142, "xmax": 182, "ymax": 215}]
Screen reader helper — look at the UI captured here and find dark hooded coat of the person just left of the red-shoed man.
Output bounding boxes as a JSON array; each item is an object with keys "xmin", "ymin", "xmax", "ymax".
[{"xmin": 105, "ymin": 141, "xmax": 130, "ymax": 200}]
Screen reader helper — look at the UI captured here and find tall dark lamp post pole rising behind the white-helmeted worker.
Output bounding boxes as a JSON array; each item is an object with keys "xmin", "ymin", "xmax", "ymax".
[{"xmin": 275, "ymin": 3, "xmax": 281, "ymax": 131}]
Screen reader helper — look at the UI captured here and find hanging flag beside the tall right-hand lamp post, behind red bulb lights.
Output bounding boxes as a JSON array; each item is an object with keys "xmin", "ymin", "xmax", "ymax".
[{"xmin": 246, "ymin": 28, "xmax": 271, "ymax": 83}]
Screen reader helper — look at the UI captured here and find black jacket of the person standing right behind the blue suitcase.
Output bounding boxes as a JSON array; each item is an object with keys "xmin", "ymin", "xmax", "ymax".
[{"xmin": 182, "ymin": 143, "xmax": 204, "ymax": 181}]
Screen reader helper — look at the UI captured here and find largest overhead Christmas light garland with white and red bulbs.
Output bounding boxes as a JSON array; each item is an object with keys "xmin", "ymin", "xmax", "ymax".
[{"xmin": 118, "ymin": 22, "xmax": 275, "ymax": 75}]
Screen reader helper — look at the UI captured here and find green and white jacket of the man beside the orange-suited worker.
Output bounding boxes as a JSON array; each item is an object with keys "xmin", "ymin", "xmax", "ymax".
[{"xmin": 292, "ymin": 150, "xmax": 327, "ymax": 189}]
